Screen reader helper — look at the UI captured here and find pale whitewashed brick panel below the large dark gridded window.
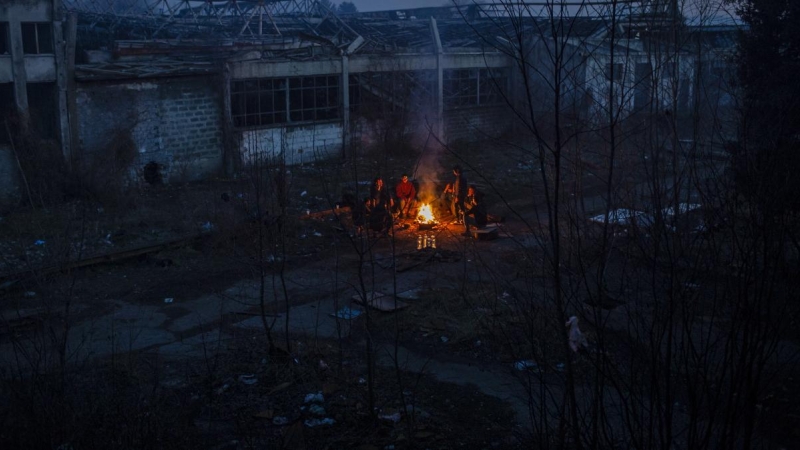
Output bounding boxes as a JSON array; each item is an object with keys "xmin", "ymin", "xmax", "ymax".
[{"xmin": 240, "ymin": 122, "xmax": 342, "ymax": 165}]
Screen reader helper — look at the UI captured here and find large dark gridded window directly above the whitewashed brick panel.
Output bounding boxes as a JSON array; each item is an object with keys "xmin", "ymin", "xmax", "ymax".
[{"xmin": 231, "ymin": 75, "xmax": 340, "ymax": 127}]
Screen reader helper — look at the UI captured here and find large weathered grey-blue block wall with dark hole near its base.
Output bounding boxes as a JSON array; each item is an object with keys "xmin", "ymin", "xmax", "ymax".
[{"xmin": 77, "ymin": 77, "xmax": 223, "ymax": 182}]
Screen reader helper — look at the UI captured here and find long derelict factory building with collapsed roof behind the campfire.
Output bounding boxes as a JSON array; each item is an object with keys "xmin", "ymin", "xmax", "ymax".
[{"xmin": 0, "ymin": 0, "xmax": 735, "ymax": 203}]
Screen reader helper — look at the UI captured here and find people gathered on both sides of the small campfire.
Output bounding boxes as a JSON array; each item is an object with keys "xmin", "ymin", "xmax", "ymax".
[{"xmin": 353, "ymin": 166, "xmax": 488, "ymax": 236}]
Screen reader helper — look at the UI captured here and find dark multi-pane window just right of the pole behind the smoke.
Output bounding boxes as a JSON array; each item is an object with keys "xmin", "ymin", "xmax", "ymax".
[{"xmin": 443, "ymin": 69, "xmax": 508, "ymax": 109}]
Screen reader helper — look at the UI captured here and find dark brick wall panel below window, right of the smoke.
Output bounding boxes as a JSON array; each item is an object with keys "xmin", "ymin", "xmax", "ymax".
[{"xmin": 444, "ymin": 106, "xmax": 513, "ymax": 142}]
